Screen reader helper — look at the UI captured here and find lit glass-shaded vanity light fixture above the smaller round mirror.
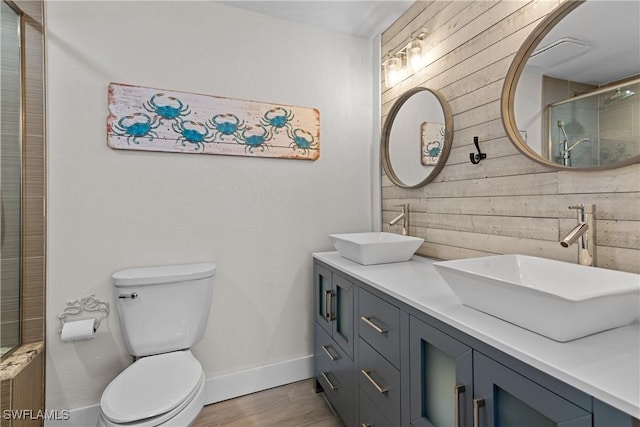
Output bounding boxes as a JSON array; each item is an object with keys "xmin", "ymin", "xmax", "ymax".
[{"xmin": 382, "ymin": 29, "xmax": 427, "ymax": 88}]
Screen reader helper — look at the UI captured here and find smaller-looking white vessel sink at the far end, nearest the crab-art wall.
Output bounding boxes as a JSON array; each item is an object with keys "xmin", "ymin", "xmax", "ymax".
[{"xmin": 329, "ymin": 232, "xmax": 424, "ymax": 265}]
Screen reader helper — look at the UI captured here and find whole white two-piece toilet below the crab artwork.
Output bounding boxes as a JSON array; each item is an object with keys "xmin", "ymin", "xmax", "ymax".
[{"xmin": 97, "ymin": 263, "xmax": 216, "ymax": 427}]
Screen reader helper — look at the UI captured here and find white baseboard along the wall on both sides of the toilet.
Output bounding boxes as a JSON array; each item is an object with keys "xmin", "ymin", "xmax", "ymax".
[{"xmin": 44, "ymin": 355, "xmax": 313, "ymax": 427}]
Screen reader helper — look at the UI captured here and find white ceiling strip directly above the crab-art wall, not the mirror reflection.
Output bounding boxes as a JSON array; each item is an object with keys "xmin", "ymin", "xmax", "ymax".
[{"xmin": 220, "ymin": 0, "xmax": 413, "ymax": 38}]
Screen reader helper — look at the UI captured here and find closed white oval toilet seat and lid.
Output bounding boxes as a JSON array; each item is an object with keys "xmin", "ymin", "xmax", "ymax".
[{"xmin": 100, "ymin": 350, "xmax": 204, "ymax": 425}]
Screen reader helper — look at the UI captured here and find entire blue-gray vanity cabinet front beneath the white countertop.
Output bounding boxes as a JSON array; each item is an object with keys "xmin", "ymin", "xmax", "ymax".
[{"xmin": 314, "ymin": 260, "xmax": 640, "ymax": 427}]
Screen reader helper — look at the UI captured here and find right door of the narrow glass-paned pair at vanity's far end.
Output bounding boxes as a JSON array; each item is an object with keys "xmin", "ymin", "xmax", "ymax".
[{"xmin": 330, "ymin": 274, "xmax": 355, "ymax": 359}]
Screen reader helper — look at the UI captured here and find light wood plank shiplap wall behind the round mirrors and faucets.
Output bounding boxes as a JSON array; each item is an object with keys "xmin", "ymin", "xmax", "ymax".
[{"xmin": 381, "ymin": 0, "xmax": 640, "ymax": 273}]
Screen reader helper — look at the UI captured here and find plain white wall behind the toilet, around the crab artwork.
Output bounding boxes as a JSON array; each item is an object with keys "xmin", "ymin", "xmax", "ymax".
[{"xmin": 46, "ymin": 1, "xmax": 374, "ymax": 409}]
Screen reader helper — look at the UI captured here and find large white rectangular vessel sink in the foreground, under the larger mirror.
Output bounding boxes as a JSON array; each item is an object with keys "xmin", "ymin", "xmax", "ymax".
[{"xmin": 434, "ymin": 255, "xmax": 640, "ymax": 342}]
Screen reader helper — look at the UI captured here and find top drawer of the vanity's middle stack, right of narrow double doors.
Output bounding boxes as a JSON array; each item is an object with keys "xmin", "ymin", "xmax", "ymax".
[{"xmin": 358, "ymin": 289, "xmax": 400, "ymax": 368}]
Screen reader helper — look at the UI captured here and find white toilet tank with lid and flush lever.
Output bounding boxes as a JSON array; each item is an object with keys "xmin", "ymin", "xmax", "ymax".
[{"xmin": 112, "ymin": 263, "xmax": 216, "ymax": 357}]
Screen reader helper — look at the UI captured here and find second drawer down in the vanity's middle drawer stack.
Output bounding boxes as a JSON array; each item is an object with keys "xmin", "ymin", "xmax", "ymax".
[{"xmin": 357, "ymin": 338, "xmax": 400, "ymax": 425}]
